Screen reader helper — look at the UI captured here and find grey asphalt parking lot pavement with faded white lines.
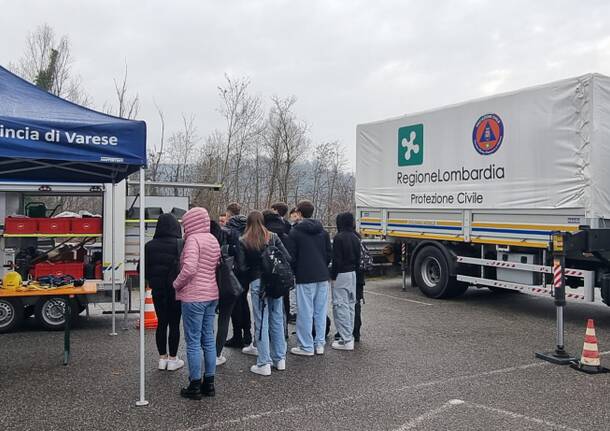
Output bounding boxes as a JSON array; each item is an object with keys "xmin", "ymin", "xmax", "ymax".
[{"xmin": 0, "ymin": 278, "xmax": 610, "ymax": 431}]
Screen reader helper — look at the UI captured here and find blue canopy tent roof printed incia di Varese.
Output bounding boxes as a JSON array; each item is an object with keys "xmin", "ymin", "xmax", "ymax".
[{"xmin": 0, "ymin": 67, "xmax": 146, "ymax": 182}]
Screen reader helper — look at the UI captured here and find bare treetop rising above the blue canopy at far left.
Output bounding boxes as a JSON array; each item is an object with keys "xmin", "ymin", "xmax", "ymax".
[{"xmin": 9, "ymin": 24, "xmax": 91, "ymax": 106}]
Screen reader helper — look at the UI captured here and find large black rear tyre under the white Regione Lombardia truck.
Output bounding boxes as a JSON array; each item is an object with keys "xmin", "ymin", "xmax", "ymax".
[{"xmin": 413, "ymin": 245, "xmax": 468, "ymax": 299}]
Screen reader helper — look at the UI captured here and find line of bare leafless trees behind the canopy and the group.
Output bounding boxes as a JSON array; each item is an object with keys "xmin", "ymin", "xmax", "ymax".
[{"xmin": 9, "ymin": 24, "xmax": 355, "ymax": 224}]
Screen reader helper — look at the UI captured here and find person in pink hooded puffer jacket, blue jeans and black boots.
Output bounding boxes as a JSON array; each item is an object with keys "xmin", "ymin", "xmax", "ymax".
[{"xmin": 174, "ymin": 207, "xmax": 220, "ymax": 399}]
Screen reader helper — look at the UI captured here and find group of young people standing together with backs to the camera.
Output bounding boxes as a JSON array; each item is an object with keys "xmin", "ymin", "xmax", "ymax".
[{"xmin": 145, "ymin": 201, "xmax": 364, "ymax": 399}]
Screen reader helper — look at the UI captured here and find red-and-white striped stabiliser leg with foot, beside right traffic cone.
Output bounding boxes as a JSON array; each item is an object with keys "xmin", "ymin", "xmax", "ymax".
[{"xmin": 536, "ymin": 232, "xmax": 577, "ymax": 365}]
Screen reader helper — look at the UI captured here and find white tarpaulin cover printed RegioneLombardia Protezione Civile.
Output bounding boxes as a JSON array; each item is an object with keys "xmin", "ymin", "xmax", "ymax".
[{"xmin": 356, "ymin": 75, "xmax": 610, "ymax": 218}]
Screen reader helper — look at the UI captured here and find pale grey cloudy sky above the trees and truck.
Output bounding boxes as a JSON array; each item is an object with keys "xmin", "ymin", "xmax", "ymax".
[{"xmin": 0, "ymin": 0, "xmax": 610, "ymax": 166}]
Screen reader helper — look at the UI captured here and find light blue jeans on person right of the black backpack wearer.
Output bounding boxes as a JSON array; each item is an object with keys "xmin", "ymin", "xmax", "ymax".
[{"xmin": 297, "ymin": 281, "xmax": 329, "ymax": 352}]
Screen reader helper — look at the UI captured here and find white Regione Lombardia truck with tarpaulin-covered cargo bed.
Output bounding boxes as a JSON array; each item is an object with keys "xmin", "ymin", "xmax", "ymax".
[{"xmin": 356, "ymin": 74, "xmax": 610, "ymax": 304}]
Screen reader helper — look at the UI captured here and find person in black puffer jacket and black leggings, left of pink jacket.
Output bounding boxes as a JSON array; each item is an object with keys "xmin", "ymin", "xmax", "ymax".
[{"xmin": 144, "ymin": 214, "xmax": 184, "ymax": 371}]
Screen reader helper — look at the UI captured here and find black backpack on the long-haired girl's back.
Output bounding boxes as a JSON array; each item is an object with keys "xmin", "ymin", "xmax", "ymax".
[{"xmin": 261, "ymin": 236, "xmax": 294, "ymax": 298}]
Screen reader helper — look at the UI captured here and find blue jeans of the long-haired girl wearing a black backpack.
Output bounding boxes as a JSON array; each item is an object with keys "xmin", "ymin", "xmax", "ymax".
[{"xmin": 250, "ymin": 279, "xmax": 286, "ymax": 366}]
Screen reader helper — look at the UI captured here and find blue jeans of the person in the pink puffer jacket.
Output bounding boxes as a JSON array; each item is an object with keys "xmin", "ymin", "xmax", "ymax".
[{"xmin": 182, "ymin": 300, "xmax": 218, "ymax": 380}]
